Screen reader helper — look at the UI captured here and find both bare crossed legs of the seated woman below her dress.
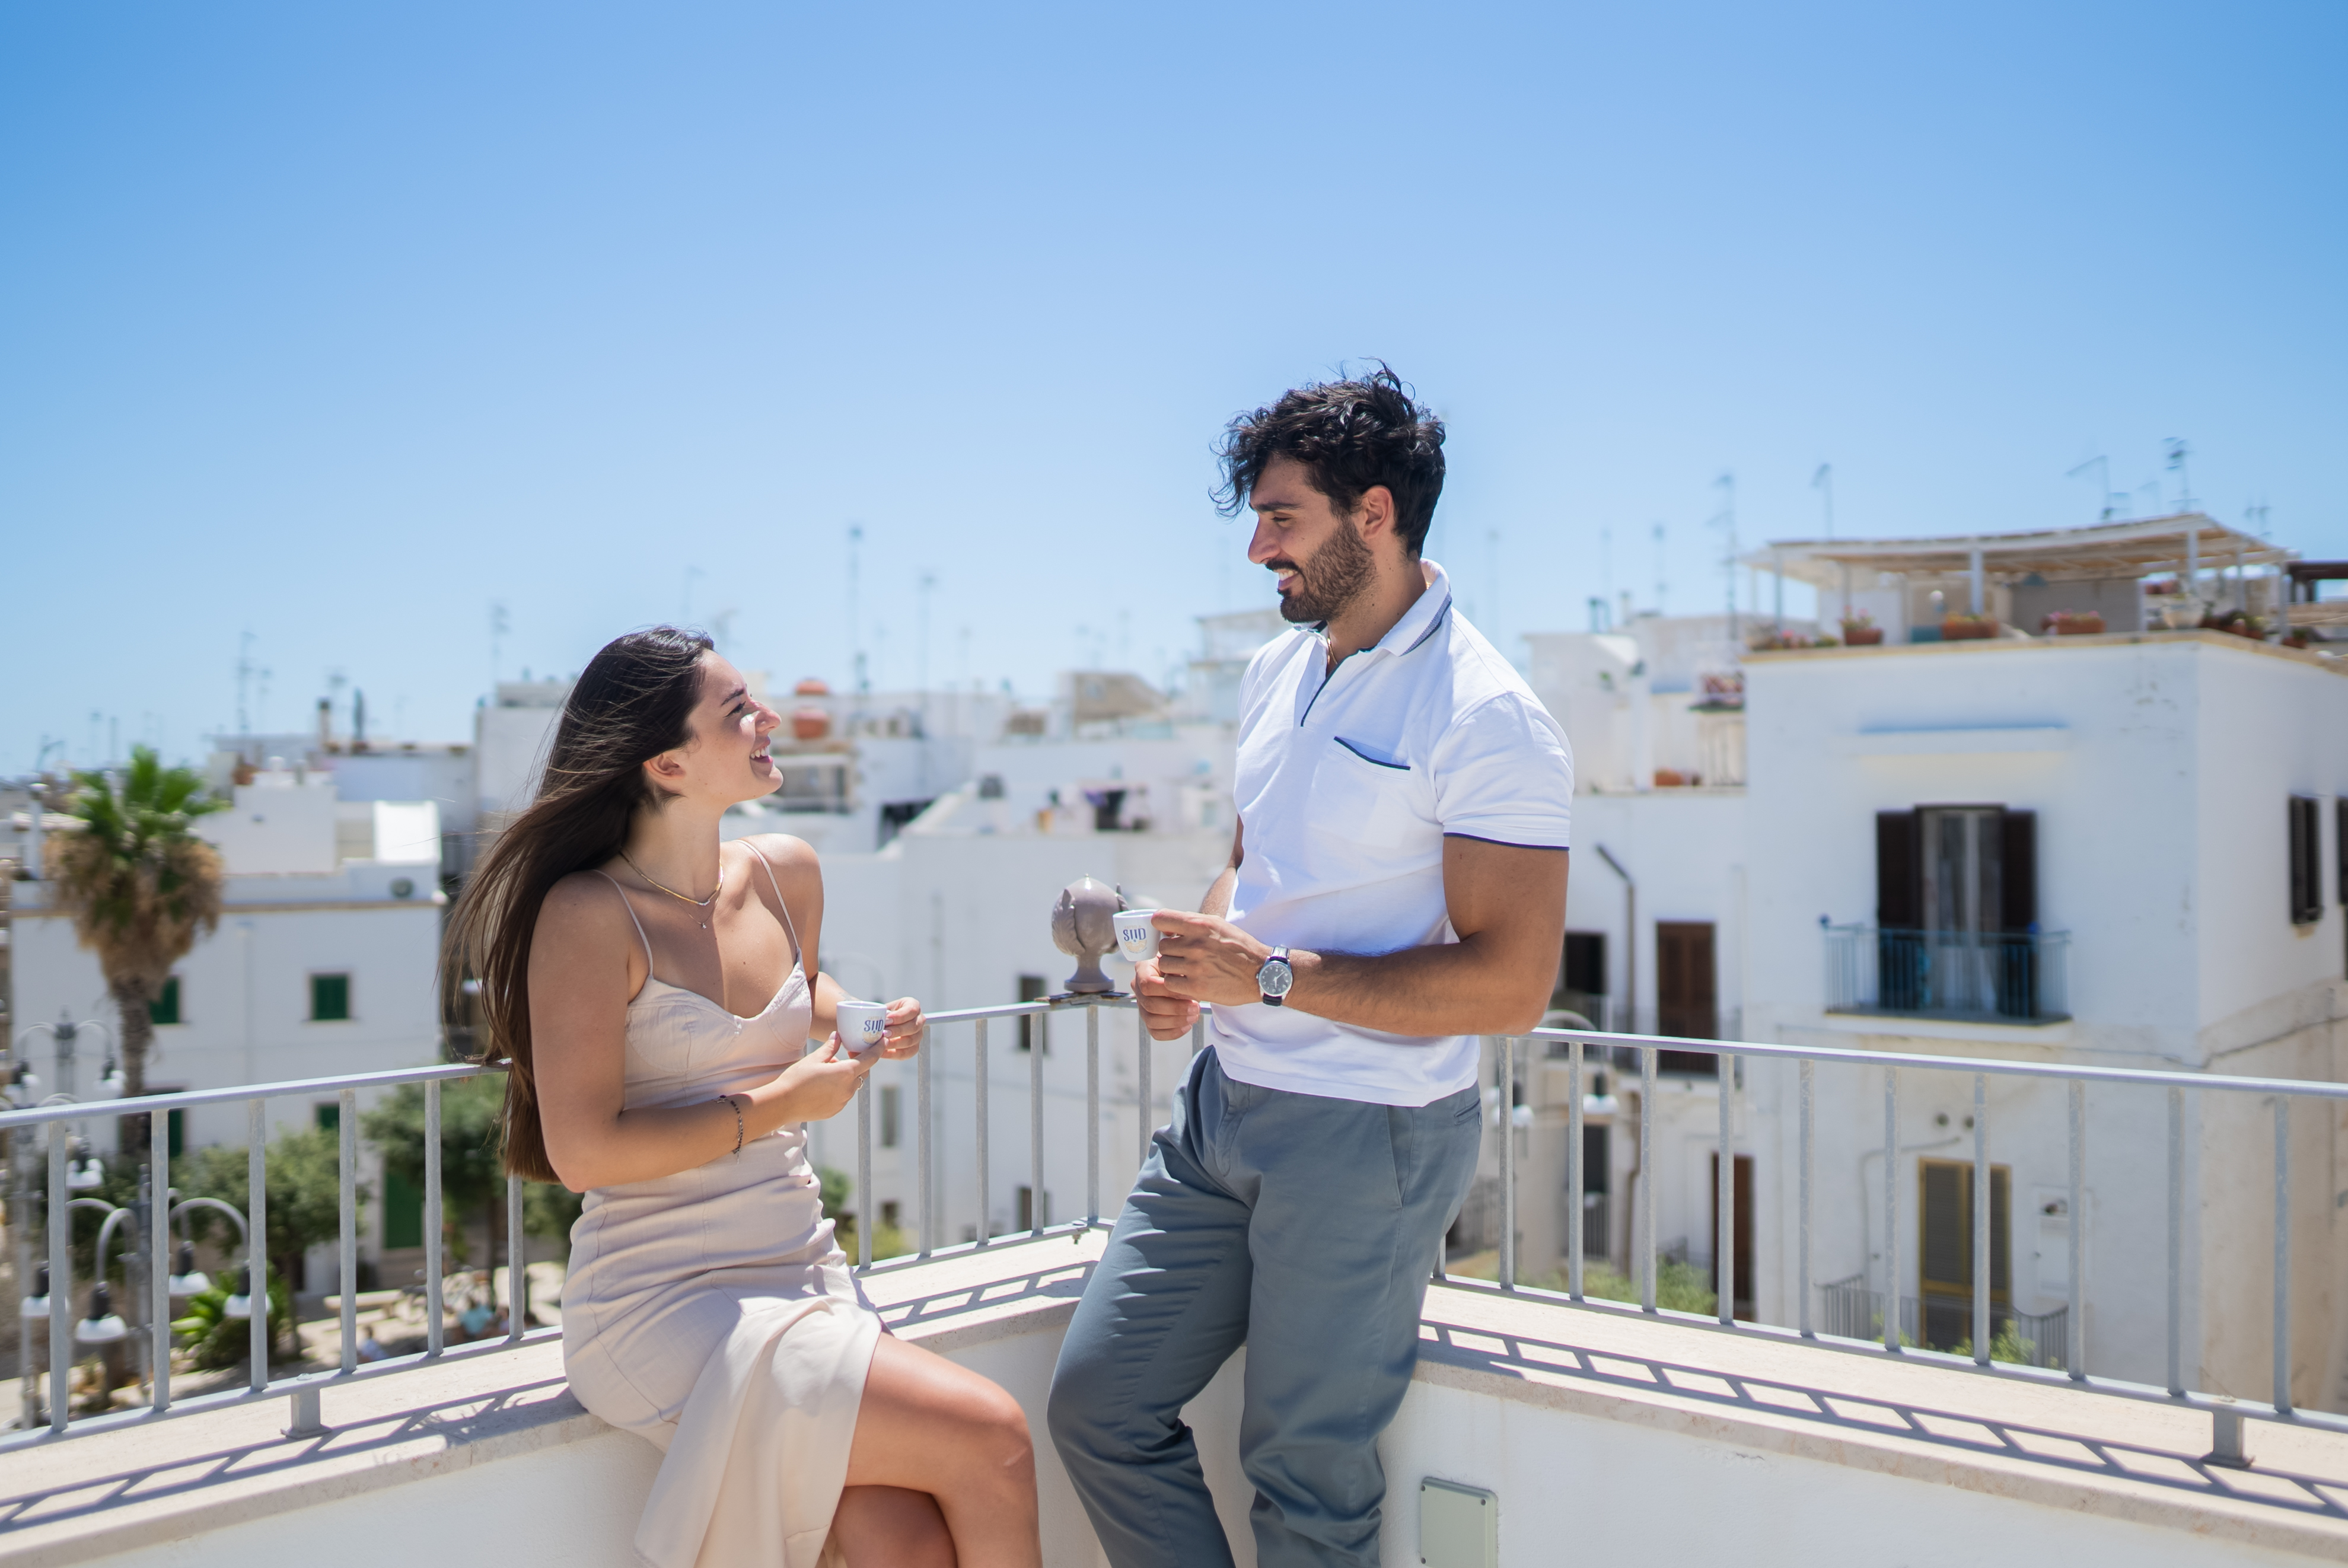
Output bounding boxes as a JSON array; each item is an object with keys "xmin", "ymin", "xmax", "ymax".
[{"xmin": 831, "ymin": 1333, "xmax": 1043, "ymax": 1568}]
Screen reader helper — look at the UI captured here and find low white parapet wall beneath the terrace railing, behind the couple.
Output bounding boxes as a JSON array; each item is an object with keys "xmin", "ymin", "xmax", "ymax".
[{"xmin": 0, "ymin": 1235, "xmax": 2348, "ymax": 1568}]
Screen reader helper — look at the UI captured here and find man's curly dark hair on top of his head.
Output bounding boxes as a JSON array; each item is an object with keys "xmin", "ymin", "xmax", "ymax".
[{"xmin": 1214, "ymin": 359, "xmax": 1444, "ymax": 559}]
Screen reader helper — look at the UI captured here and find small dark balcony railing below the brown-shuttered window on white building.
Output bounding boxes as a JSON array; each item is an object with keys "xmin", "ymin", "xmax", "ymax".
[{"xmin": 1824, "ymin": 925, "xmax": 2071, "ymax": 1024}]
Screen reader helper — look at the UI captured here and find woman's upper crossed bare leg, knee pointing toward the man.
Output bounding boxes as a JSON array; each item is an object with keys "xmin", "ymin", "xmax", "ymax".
[{"xmin": 840, "ymin": 1336, "xmax": 1043, "ymax": 1568}]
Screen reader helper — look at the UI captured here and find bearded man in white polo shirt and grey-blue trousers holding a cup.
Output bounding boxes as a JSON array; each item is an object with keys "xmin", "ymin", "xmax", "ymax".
[{"xmin": 1050, "ymin": 366, "xmax": 1573, "ymax": 1568}]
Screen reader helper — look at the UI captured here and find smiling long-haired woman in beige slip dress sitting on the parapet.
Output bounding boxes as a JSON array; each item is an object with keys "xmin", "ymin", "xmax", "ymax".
[{"xmin": 444, "ymin": 627, "xmax": 1043, "ymax": 1568}]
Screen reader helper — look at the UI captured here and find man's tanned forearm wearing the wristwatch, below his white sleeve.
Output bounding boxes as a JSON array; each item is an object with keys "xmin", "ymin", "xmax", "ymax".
[{"xmin": 1287, "ymin": 936, "xmax": 1550, "ymax": 1035}]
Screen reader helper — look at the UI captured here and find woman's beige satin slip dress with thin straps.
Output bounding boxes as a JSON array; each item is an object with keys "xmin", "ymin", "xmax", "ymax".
[{"xmin": 563, "ymin": 850, "xmax": 881, "ymax": 1568}]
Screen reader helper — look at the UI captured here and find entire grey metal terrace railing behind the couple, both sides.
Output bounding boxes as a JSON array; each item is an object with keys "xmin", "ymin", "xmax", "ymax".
[{"xmin": 0, "ymin": 995, "xmax": 2348, "ymax": 1462}]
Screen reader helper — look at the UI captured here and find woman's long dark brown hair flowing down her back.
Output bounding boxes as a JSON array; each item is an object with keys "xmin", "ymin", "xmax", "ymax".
[{"xmin": 439, "ymin": 627, "xmax": 712, "ymax": 1181}]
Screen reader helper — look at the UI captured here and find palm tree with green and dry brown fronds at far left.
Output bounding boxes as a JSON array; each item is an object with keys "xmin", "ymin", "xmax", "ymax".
[{"xmin": 47, "ymin": 747, "xmax": 228, "ymax": 1126}]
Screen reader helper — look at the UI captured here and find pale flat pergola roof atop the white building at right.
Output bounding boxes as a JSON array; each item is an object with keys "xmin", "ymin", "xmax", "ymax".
[{"xmin": 1742, "ymin": 512, "xmax": 2294, "ymax": 610}]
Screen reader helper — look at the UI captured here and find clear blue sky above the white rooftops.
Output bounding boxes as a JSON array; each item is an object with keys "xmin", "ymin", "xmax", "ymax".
[{"xmin": 0, "ymin": 2, "xmax": 2348, "ymax": 772}]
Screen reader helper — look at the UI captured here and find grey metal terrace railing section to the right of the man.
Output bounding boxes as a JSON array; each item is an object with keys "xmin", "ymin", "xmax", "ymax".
[{"xmin": 1465, "ymin": 1028, "xmax": 2348, "ymax": 1465}]
